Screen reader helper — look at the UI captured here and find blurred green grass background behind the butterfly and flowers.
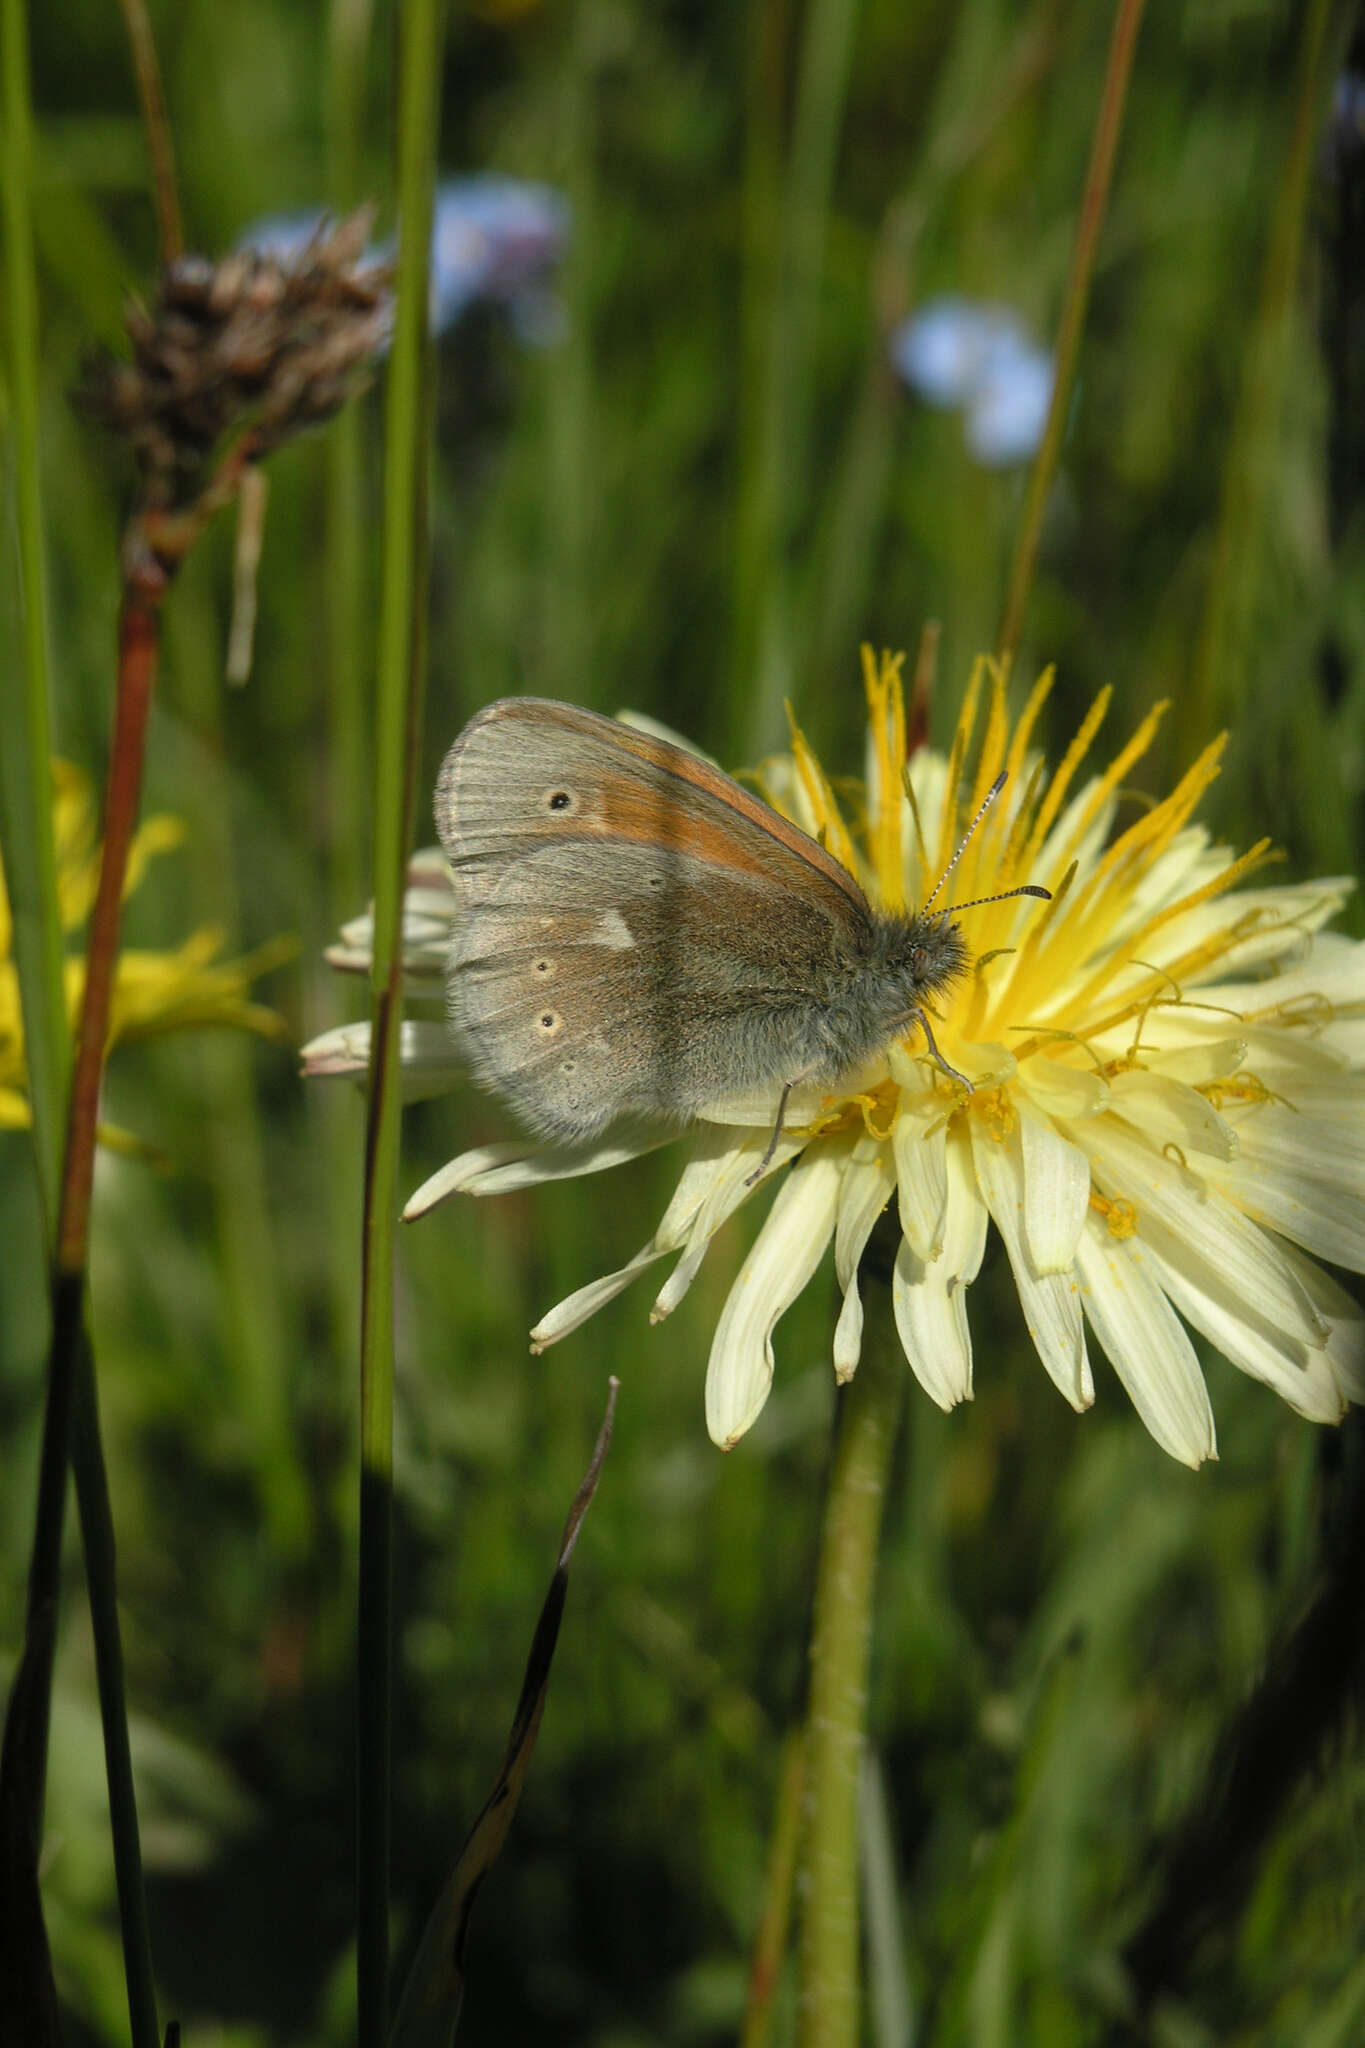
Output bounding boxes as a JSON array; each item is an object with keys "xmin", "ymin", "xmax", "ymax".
[{"xmin": 0, "ymin": 0, "xmax": 1365, "ymax": 2048}]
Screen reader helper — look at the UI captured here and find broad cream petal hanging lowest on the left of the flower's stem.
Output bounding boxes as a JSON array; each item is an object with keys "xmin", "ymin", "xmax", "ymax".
[{"xmin": 706, "ymin": 1149, "xmax": 843, "ymax": 1450}]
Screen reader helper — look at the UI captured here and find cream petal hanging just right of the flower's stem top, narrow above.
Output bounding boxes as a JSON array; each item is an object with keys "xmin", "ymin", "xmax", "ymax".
[{"xmin": 890, "ymin": 1130, "xmax": 986, "ymax": 1409}]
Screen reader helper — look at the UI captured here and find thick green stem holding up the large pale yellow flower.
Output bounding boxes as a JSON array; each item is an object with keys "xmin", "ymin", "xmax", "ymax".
[{"xmin": 800, "ymin": 1262, "xmax": 905, "ymax": 2048}]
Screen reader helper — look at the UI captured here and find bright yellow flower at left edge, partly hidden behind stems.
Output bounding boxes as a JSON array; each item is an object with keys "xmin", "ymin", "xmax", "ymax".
[{"xmin": 0, "ymin": 762, "xmax": 287, "ymax": 1145}]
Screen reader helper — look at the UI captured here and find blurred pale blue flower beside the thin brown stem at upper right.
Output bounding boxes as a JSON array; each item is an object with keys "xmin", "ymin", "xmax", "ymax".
[{"xmin": 890, "ymin": 297, "xmax": 1054, "ymax": 469}]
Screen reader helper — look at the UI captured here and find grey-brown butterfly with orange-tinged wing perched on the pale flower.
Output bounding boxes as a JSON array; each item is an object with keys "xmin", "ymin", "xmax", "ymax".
[{"xmin": 436, "ymin": 696, "xmax": 968, "ymax": 1143}]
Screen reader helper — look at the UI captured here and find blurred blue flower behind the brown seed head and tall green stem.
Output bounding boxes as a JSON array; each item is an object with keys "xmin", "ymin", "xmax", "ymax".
[{"xmin": 239, "ymin": 174, "xmax": 569, "ymax": 344}]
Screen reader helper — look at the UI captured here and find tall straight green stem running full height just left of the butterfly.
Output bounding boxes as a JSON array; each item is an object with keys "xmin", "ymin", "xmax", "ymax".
[{"xmin": 356, "ymin": 0, "xmax": 444, "ymax": 2048}]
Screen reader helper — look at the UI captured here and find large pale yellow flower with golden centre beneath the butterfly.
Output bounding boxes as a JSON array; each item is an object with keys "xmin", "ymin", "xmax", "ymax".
[{"xmin": 305, "ymin": 655, "xmax": 1365, "ymax": 1464}]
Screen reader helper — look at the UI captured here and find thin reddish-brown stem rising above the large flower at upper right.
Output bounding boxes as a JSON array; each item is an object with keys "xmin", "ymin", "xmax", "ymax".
[{"xmin": 997, "ymin": 0, "xmax": 1144, "ymax": 662}]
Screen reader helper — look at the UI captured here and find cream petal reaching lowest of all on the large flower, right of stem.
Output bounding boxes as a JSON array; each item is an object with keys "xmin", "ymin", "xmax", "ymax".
[{"xmin": 1076, "ymin": 1217, "xmax": 1218, "ymax": 1466}]
